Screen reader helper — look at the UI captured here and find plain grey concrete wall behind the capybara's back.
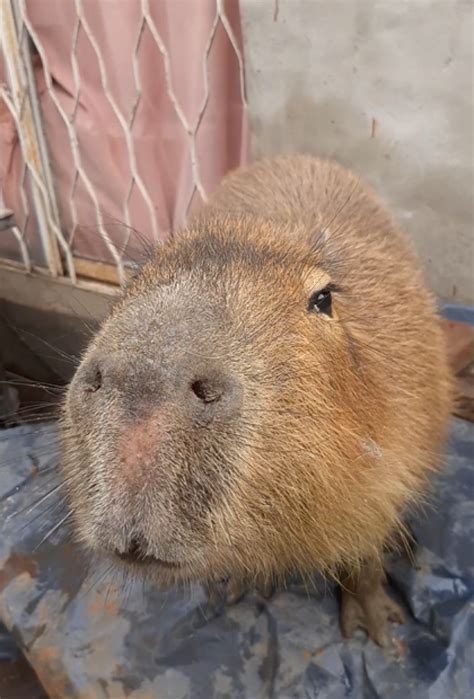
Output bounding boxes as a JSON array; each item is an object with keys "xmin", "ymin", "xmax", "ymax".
[{"xmin": 241, "ymin": 0, "xmax": 474, "ymax": 302}]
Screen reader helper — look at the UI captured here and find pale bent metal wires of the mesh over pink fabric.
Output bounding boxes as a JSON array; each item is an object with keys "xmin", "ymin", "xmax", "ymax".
[{"xmin": 0, "ymin": 0, "xmax": 246, "ymax": 283}]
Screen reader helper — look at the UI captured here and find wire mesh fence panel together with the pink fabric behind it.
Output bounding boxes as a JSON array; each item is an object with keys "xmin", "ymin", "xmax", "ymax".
[{"xmin": 0, "ymin": 0, "xmax": 247, "ymax": 282}]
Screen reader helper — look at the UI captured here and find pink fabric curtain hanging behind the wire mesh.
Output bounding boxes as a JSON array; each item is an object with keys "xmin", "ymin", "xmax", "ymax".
[{"xmin": 0, "ymin": 0, "xmax": 248, "ymax": 262}]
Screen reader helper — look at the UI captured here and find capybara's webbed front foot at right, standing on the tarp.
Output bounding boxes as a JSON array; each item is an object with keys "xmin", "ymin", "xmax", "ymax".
[{"xmin": 341, "ymin": 563, "xmax": 404, "ymax": 647}]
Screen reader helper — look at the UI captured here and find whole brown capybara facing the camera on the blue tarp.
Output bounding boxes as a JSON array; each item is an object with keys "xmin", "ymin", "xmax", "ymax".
[{"xmin": 62, "ymin": 156, "xmax": 451, "ymax": 644}]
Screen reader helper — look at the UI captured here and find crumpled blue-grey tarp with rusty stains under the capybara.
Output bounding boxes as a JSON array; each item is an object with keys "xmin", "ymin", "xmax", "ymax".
[{"xmin": 0, "ymin": 420, "xmax": 474, "ymax": 699}]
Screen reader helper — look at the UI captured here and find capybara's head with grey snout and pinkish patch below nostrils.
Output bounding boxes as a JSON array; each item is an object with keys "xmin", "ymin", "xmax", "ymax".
[{"xmin": 63, "ymin": 219, "xmax": 362, "ymax": 577}]
